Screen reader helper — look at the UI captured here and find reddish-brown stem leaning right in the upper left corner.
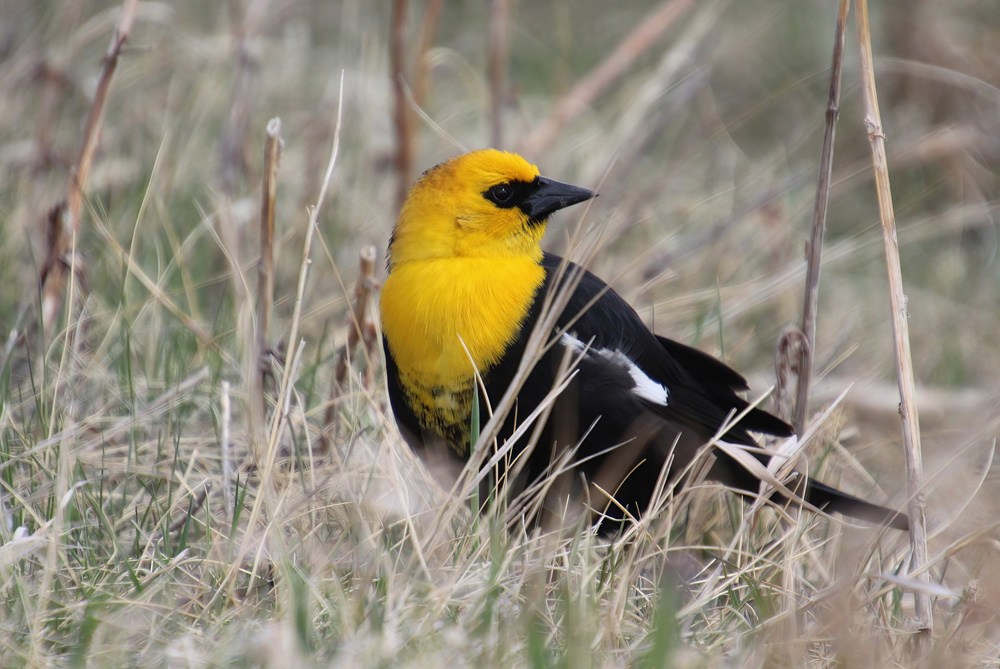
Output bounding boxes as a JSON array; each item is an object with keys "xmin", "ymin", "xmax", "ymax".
[{"xmin": 41, "ymin": 0, "xmax": 139, "ymax": 338}]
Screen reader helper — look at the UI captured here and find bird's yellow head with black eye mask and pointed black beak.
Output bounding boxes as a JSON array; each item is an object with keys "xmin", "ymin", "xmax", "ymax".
[{"xmin": 389, "ymin": 149, "xmax": 593, "ymax": 270}]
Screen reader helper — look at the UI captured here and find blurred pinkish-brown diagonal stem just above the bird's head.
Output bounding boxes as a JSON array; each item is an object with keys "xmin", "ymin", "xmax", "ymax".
[{"xmin": 521, "ymin": 0, "xmax": 694, "ymax": 157}]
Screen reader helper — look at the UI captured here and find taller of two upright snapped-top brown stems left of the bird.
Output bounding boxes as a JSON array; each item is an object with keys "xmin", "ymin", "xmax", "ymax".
[{"xmin": 250, "ymin": 117, "xmax": 281, "ymax": 436}]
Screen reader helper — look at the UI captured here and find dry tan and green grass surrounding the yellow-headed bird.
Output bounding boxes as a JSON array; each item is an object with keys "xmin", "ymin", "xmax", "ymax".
[{"xmin": 0, "ymin": 0, "xmax": 1000, "ymax": 667}]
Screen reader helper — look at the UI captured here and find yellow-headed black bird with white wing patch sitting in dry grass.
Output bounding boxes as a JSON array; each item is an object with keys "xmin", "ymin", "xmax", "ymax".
[{"xmin": 379, "ymin": 149, "xmax": 909, "ymax": 530}]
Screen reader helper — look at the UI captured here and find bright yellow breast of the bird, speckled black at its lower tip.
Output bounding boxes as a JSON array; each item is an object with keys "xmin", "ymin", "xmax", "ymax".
[{"xmin": 381, "ymin": 257, "xmax": 545, "ymax": 445}]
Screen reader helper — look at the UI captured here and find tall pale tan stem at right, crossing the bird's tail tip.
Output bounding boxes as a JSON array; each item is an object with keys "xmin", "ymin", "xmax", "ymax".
[{"xmin": 855, "ymin": 0, "xmax": 933, "ymax": 638}]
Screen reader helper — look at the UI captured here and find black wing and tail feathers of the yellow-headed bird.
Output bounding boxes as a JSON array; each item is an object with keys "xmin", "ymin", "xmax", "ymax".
[{"xmin": 537, "ymin": 254, "xmax": 909, "ymax": 530}]
